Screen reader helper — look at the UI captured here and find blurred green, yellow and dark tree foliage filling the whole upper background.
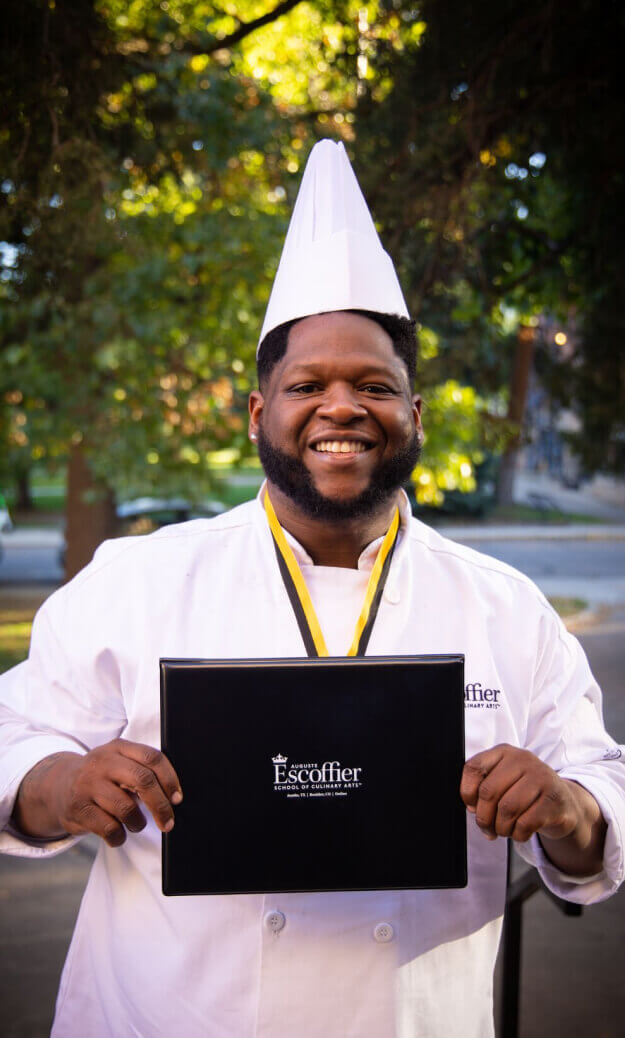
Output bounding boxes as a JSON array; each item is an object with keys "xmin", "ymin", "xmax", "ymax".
[{"xmin": 0, "ymin": 0, "xmax": 624, "ymax": 519}]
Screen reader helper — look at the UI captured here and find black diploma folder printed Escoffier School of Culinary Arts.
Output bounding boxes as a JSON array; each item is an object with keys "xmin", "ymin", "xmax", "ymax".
[{"xmin": 160, "ymin": 656, "xmax": 466, "ymax": 895}]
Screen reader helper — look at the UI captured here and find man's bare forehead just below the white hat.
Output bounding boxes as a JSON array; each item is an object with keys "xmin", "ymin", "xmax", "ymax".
[{"xmin": 278, "ymin": 311, "xmax": 407, "ymax": 381}]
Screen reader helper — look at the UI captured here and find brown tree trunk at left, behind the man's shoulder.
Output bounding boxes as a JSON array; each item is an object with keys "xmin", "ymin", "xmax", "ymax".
[{"xmin": 65, "ymin": 446, "xmax": 115, "ymax": 580}]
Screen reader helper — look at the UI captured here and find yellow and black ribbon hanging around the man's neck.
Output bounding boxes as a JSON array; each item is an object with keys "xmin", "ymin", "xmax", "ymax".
[{"xmin": 265, "ymin": 491, "xmax": 400, "ymax": 656}]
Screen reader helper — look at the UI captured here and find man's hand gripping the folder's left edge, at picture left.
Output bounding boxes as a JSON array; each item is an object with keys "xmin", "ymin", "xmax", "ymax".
[{"xmin": 11, "ymin": 739, "xmax": 183, "ymax": 847}]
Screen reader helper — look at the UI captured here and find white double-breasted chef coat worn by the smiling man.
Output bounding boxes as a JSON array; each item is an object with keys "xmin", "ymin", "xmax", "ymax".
[{"xmin": 0, "ymin": 499, "xmax": 625, "ymax": 1038}]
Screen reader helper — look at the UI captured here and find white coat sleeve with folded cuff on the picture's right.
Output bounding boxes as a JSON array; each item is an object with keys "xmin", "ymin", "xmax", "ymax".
[{"xmin": 515, "ymin": 607, "xmax": 625, "ymax": 904}]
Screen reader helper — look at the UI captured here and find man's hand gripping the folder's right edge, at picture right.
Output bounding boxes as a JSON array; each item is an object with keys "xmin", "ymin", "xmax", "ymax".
[{"xmin": 460, "ymin": 743, "xmax": 605, "ymax": 875}]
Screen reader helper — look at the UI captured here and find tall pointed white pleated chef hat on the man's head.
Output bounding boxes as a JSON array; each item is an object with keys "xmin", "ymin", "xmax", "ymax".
[{"xmin": 259, "ymin": 140, "xmax": 409, "ymax": 347}]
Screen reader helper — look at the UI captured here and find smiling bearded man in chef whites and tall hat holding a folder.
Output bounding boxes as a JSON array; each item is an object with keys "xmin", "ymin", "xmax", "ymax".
[{"xmin": 0, "ymin": 142, "xmax": 625, "ymax": 1038}]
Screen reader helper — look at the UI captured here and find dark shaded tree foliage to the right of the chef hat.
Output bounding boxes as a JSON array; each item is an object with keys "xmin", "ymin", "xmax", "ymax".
[{"xmin": 354, "ymin": 0, "xmax": 625, "ymax": 489}]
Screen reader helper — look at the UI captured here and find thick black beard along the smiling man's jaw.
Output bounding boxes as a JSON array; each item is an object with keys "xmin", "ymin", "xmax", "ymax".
[{"xmin": 257, "ymin": 427, "xmax": 420, "ymax": 522}]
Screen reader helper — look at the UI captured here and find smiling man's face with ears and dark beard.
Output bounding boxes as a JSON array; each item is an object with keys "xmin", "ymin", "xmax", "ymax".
[{"xmin": 249, "ymin": 312, "xmax": 422, "ymax": 519}]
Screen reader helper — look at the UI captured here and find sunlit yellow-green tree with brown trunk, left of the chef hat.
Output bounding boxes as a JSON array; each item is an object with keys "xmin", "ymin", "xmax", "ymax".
[{"xmin": 0, "ymin": 0, "xmax": 490, "ymax": 575}]
